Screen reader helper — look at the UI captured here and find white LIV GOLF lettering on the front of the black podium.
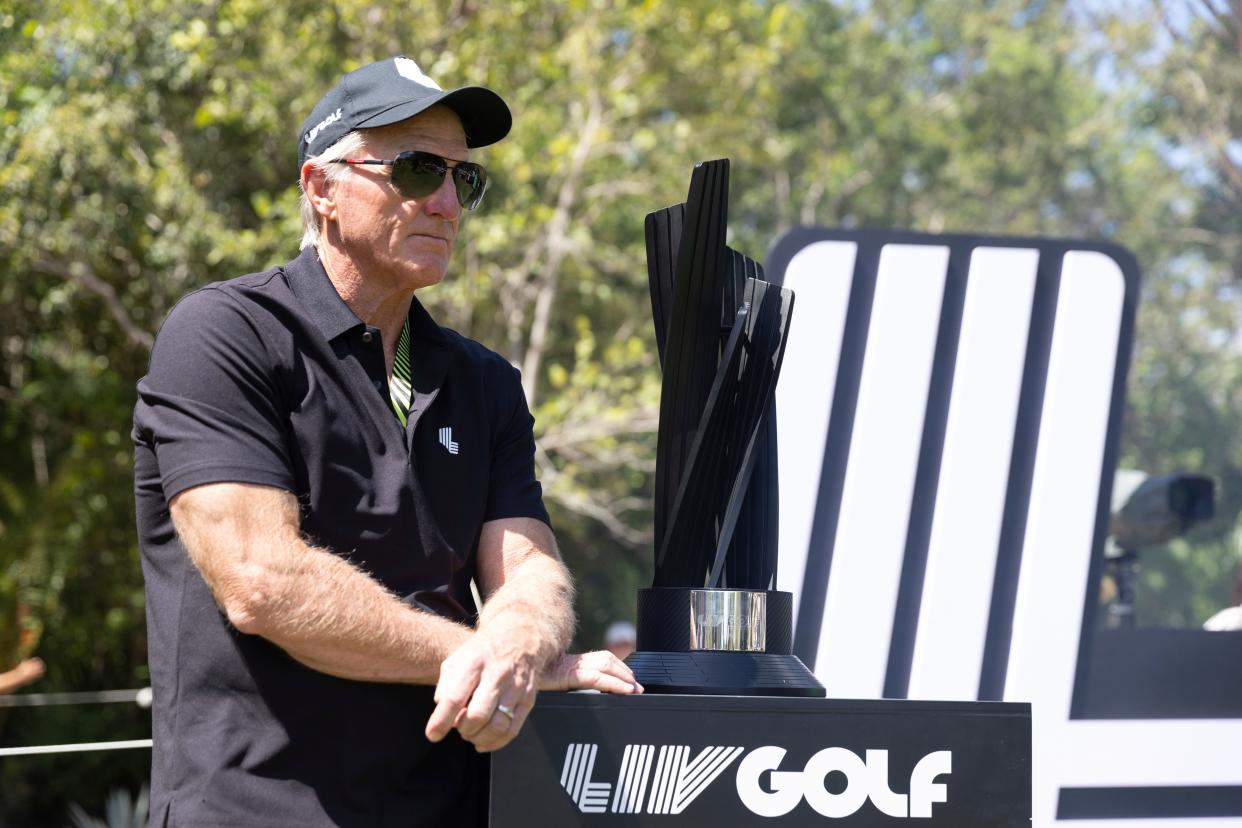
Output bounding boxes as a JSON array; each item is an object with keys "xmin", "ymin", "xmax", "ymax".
[{"xmin": 560, "ymin": 744, "xmax": 953, "ymax": 818}]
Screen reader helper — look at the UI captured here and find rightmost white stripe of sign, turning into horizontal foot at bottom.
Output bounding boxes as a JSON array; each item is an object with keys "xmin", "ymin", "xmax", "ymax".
[{"xmin": 1005, "ymin": 252, "xmax": 1242, "ymax": 828}]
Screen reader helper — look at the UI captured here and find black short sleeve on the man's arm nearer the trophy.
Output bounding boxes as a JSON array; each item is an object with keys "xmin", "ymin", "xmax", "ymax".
[{"xmin": 484, "ymin": 362, "xmax": 551, "ymax": 526}]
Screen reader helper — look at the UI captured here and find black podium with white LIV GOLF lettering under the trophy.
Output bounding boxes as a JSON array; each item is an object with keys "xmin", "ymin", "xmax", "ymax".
[{"xmin": 489, "ymin": 693, "xmax": 1031, "ymax": 828}]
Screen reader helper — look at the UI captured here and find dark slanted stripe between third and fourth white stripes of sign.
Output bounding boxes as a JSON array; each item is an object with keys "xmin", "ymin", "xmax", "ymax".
[{"xmin": 979, "ymin": 247, "xmax": 1064, "ymax": 701}]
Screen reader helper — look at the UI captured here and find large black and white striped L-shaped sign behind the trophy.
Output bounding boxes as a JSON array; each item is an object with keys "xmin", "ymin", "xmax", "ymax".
[{"xmin": 768, "ymin": 228, "xmax": 1242, "ymax": 828}]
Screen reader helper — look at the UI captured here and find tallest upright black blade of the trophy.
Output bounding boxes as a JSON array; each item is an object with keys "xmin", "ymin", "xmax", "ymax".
[{"xmin": 655, "ymin": 159, "xmax": 729, "ymax": 586}]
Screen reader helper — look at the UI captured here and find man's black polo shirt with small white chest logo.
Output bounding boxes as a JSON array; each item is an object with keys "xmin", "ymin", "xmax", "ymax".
[{"xmin": 133, "ymin": 250, "xmax": 548, "ymax": 828}]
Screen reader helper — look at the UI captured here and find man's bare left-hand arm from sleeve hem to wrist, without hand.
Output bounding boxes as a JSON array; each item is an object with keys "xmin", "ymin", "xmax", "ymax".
[{"xmin": 173, "ymin": 484, "xmax": 471, "ymax": 684}]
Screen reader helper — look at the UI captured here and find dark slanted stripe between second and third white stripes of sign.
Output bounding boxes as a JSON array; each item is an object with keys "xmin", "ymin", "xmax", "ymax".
[{"xmin": 884, "ymin": 243, "xmax": 971, "ymax": 699}]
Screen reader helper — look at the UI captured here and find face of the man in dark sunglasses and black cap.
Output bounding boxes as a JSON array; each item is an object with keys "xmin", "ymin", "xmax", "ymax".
[{"xmin": 328, "ymin": 107, "xmax": 469, "ymax": 290}]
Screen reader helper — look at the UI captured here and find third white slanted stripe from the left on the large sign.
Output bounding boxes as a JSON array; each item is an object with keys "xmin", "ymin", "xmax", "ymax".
[{"xmin": 909, "ymin": 247, "xmax": 1040, "ymax": 700}]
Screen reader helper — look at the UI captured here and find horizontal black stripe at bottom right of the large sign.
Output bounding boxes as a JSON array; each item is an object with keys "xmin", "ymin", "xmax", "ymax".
[{"xmin": 1057, "ymin": 785, "xmax": 1242, "ymax": 819}]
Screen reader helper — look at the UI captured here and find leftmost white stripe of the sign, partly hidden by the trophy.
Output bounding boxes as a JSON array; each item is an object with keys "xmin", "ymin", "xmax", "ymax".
[{"xmin": 776, "ymin": 242, "xmax": 858, "ymax": 621}]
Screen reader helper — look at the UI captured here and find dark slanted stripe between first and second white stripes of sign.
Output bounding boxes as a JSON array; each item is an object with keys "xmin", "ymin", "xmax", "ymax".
[{"xmin": 794, "ymin": 242, "xmax": 883, "ymax": 670}]
